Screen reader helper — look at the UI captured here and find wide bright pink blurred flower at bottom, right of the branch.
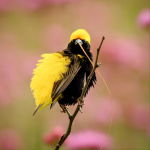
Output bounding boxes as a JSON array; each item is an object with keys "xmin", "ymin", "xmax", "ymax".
[{"xmin": 65, "ymin": 130, "xmax": 112, "ymax": 150}]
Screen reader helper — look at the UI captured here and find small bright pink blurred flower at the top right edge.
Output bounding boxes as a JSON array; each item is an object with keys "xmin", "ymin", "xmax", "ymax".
[{"xmin": 137, "ymin": 9, "xmax": 150, "ymax": 28}]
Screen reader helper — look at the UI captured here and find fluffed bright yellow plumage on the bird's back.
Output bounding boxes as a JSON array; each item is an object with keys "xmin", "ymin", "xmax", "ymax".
[{"xmin": 30, "ymin": 53, "xmax": 70, "ymax": 109}]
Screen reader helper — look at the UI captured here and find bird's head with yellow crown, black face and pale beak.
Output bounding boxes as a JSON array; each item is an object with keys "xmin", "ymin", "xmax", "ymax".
[{"xmin": 68, "ymin": 29, "xmax": 91, "ymax": 54}]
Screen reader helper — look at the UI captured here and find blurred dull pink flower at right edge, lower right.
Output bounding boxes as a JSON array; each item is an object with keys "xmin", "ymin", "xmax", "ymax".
[{"xmin": 127, "ymin": 104, "xmax": 150, "ymax": 130}]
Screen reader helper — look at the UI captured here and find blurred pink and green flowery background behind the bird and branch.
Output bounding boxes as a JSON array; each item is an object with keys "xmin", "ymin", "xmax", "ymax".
[{"xmin": 0, "ymin": 0, "xmax": 150, "ymax": 150}]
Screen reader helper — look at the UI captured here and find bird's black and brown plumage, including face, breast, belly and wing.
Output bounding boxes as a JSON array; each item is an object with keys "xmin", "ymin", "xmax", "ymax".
[{"xmin": 51, "ymin": 40, "xmax": 97, "ymax": 107}]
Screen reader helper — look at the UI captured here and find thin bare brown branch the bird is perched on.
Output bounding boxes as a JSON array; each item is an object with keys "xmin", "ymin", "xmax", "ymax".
[{"xmin": 55, "ymin": 36, "xmax": 105, "ymax": 150}]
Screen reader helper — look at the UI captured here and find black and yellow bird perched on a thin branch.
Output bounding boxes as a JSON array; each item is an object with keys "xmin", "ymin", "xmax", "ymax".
[{"xmin": 30, "ymin": 29, "xmax": 97, "ymax": 115}]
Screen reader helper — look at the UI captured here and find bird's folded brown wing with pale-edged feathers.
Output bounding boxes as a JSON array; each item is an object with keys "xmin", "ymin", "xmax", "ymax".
[{"xmin": 51, "ymin": 56, "xmax": 81, "ymax": 106}]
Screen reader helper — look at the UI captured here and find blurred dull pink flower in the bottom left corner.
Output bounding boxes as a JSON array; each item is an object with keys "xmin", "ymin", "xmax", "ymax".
[{"xmin": 0, "ymin": 129, "xmax": 22, "ymax": 150}]
